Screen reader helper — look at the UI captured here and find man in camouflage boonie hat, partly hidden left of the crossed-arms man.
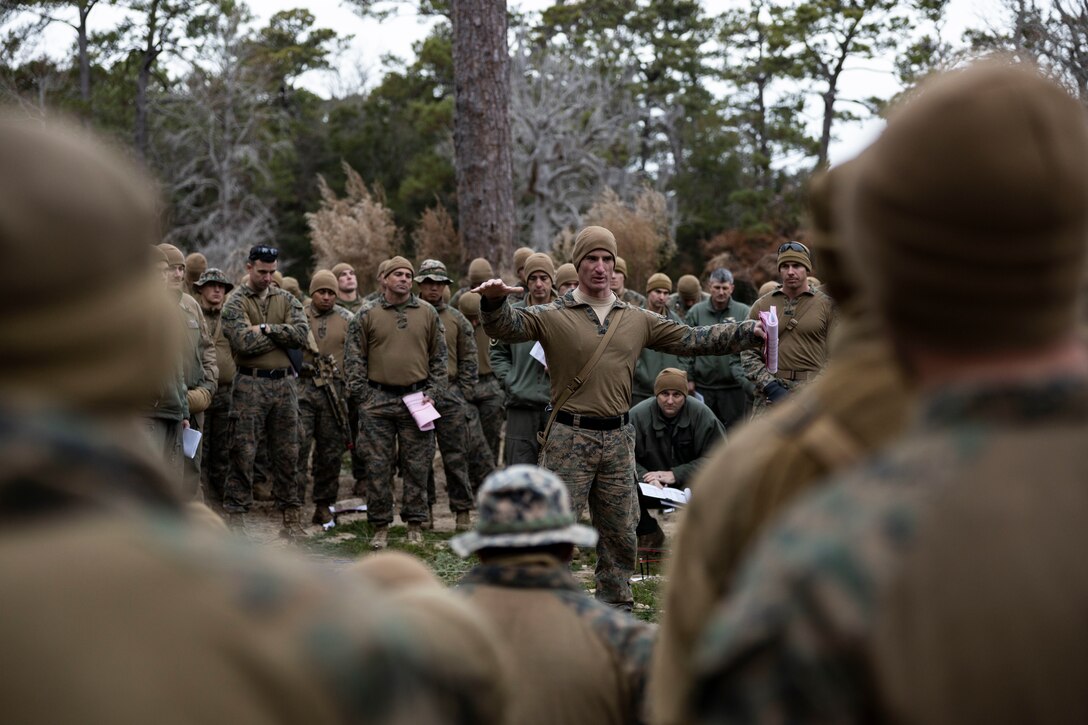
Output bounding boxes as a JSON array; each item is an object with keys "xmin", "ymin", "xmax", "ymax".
[{"xmin": 195, "ymin": 267, "xmax": 237, "ymax": 512}]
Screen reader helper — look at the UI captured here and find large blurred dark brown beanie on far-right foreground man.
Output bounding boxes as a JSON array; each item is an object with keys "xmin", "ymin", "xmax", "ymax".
[{"xmin": 844, "ymin": 61, "xmax": 1088, "ymax": 354}]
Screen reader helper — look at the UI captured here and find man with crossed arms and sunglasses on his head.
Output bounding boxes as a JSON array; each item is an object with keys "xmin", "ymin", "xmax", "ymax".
[{"xmin": 223, "ymin": 244, "xmax": 309, "ymax": 539}]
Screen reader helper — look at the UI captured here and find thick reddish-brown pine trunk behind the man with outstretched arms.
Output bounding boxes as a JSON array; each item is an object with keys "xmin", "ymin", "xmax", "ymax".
[{"xmin": 453, "ymin": 0, "xmax": 517, "ymax": 271}]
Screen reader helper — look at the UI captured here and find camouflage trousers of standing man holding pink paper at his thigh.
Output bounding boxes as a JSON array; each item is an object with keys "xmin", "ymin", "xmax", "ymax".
[{"xmin": 356, "ymin": 389, "xmax": 434, "ymax": 526}]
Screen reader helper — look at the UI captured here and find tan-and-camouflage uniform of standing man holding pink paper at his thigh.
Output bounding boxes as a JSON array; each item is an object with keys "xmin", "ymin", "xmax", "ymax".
[{"xmin": 344, "ymin": 295, "xmax": 447, "ymax": 526}]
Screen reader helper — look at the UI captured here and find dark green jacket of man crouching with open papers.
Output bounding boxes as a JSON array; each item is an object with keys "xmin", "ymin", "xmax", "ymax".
[{"xmin": 631, "ymin": 395, "xmax": 726, "ymax": 487}]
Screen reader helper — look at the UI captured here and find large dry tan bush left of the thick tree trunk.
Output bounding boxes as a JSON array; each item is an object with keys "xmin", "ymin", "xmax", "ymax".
[{"xmin": 306, "ymin": 162, "xmax": 404, "ymax": 290}]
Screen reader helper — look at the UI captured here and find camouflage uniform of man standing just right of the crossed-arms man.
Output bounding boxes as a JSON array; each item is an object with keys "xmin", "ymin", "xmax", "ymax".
[{"xmin": 297, "ymin": 302, "xmax": 351, "ymax": 505}]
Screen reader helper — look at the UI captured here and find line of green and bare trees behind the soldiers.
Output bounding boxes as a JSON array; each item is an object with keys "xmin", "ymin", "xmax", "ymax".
[{"xmin": 0, "ymin": 0, "xmax": 1088, "ymax": 288}]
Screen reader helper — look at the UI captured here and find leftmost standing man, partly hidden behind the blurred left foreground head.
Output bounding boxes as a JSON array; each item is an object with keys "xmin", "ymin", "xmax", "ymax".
[{"xmin": 159, "ymin": 244, "xmax": 219, "ymax": 499}]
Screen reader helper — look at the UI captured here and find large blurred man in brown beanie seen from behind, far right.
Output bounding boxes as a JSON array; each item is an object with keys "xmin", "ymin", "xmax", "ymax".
[{"xmin": 693, "ymin": 62, "xmax": 1088, "ymax": 723}]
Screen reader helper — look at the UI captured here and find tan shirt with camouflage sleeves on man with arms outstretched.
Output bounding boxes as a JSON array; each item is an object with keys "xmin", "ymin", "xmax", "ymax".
[{"xmin": 480, "ymin": 293, "xmax": 762, "ymax": 417}]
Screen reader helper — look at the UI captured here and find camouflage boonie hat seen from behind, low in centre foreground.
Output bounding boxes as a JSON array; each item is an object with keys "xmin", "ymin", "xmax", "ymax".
[{"xmin": 449, "ymin": 465, "xmax": 597, "ymax": 556}]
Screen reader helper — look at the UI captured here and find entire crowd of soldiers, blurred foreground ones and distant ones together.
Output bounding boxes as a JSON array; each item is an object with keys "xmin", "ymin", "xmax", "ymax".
[{"xmin": 0, "ymin": 61, "xmax": 1088, "ymax": 725}]
